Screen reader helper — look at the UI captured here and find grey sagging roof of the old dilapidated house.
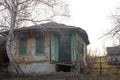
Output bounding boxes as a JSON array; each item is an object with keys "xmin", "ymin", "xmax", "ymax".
[{"xmin": 15, "ymin": 22, "xmax": 89, "ymax": 44}]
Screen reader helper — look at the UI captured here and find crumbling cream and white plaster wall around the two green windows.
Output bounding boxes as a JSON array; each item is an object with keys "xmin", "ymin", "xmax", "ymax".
[{"xmin": 9, "ymin": 36, "xmax": 55, "ymax": 74}]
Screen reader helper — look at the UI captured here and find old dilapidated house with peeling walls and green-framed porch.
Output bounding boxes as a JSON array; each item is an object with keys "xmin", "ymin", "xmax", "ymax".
[{"xmin": 1, "ymin": 22, "xmax": 89, "ymax": 74}]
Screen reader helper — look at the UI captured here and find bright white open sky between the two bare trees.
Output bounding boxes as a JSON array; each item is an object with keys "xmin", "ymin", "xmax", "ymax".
[{"xmin": 65, "ymin": 0, "xmax": 120, "ymax": 53}]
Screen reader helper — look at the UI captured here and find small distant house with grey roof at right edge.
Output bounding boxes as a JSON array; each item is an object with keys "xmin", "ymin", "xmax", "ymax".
[{"xmin": 107, "ymin": 46, "xmax": 120, "ymax": 64}]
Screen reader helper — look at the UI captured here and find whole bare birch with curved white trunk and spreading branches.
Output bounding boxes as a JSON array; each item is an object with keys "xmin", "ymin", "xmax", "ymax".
[{"xmin": 0, "ymin": 0, "xmax": 69, "ymax": 76}]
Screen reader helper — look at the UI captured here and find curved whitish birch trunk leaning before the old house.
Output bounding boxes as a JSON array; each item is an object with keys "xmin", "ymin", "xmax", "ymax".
[{"xmin": 6, "ymin": 11, "xmax": 24, "ymax": 76}]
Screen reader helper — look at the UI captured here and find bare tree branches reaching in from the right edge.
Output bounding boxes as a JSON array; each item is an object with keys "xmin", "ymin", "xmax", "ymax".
[{"xmin": 100, "ymin": 8, "xmax": 120, "ymax": 45}]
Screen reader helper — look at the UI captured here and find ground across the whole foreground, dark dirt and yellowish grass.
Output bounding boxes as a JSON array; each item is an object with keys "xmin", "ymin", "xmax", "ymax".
[{"xmin": 0, "ymin": 63, "xmax": 120, "ymax": 80}]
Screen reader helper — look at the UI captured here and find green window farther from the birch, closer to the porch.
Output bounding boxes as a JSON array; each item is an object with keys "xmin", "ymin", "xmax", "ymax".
[{"xmin": 36, "ymin": 37, "xmax": 45, "ymax": 55}]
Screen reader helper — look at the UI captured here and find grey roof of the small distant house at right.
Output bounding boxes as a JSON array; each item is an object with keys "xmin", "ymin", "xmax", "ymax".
[{"xmin": 107, "ymin": 45, "xmax": 120, "ymax": 55}]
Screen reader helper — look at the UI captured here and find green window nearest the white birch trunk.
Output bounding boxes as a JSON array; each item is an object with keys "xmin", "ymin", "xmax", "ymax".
[{"xmin": 19, "ymin": 39, "xmax": 27, "ymax": 55}]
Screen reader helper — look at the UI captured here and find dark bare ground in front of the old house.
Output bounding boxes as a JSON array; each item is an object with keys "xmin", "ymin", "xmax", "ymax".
[{"xmin": 0, "ymin": 72, "xmax": 78, "ymax": 80}]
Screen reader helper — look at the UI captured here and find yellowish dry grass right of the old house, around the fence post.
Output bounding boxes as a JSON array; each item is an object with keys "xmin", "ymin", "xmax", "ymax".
[{"xmin": 80, "ymin": 61, "xmax": 120, "ymax": 80}]
